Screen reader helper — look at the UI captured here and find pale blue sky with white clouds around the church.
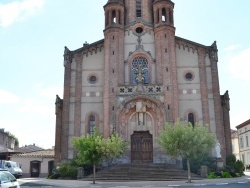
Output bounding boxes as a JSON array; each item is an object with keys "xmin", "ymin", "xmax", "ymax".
[{"xmin": 0, "ymin": 0, "xmax": 250, "ymax": 149}]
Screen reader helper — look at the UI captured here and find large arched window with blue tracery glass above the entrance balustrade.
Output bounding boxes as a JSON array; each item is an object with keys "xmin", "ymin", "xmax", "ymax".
[{"xmin": 132, "ymin": 56, "xmax": 148, "ymax": 85}]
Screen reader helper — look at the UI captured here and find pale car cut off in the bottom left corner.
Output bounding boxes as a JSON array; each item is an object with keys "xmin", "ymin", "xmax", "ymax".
[{"xmin": 0, "ymin": 170, "xmax": 20, "ymax": 188}]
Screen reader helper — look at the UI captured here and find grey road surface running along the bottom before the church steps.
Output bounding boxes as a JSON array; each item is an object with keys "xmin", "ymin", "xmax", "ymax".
[{"xmin": 18, "ymin": 177, "xmax": 250, "ymax": 188}]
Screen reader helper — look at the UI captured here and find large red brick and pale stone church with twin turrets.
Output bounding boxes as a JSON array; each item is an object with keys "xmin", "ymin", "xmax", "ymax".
[{"xmin": 55, "ymin": 0, "xmax": 232, "ymax": 163}]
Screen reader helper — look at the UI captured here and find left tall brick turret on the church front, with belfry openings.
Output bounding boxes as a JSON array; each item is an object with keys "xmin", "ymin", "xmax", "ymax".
[{"xmin": 103, "ymin": 0, "xmax": 125, "ymax": 137}]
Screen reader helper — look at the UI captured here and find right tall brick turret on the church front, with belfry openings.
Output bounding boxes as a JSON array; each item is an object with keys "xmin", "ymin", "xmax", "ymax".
[{"xmin": 153, "ymin": 0, "xmax": 179, "ymax": 120}]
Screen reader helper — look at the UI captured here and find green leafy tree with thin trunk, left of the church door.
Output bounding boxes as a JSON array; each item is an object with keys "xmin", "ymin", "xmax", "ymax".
[{"xmin": 73, "ymin": 128, "xmax": 126, "ymax": 184}]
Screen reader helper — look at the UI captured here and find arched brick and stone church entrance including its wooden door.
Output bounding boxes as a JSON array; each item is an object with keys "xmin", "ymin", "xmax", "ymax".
[{"xmin": 116, "ymin": 95, "xmax": 167, "ymax": 163}]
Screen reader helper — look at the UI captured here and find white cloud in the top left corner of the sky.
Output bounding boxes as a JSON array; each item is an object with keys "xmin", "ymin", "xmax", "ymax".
[{"xmin": 0, "ymin": 0, "xmax": 45, "ymax": 27}]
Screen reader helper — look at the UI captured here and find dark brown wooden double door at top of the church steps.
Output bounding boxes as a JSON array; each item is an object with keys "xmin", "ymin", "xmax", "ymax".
[{"xmin": 131, "ymin": 131, "xmax": 153, "ymax": 163}]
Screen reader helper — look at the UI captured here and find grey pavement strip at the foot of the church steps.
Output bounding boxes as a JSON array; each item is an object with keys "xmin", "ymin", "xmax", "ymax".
[{"xmin": 18, "ymin": 172, "xmax": 250, "ymax": 188}]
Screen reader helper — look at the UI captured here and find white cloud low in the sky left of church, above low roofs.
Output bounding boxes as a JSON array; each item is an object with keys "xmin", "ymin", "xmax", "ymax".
[{"xmin": 0, "ymin": 83, "xmax": 62, "ymax": 148}]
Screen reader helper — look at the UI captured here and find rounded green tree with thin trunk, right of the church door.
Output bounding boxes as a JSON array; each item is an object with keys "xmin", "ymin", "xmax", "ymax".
[{"xmin": 158, "ymin": 120, "xmax": 216, "ymax": 182}]
